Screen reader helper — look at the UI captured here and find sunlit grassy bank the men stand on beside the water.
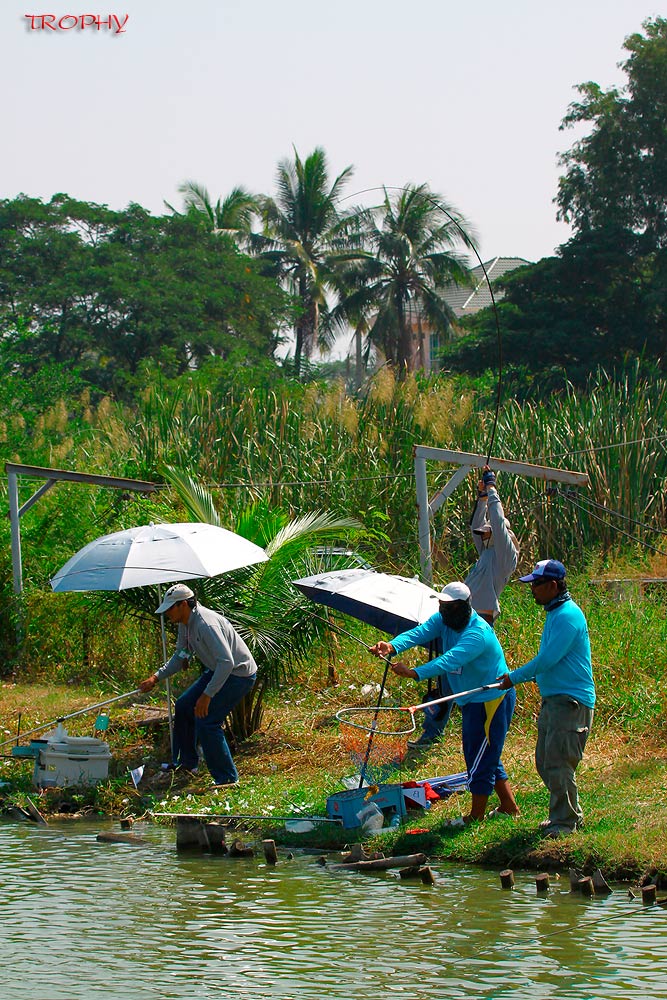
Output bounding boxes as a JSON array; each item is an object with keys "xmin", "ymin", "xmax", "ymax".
[{"xmin": 0, "ymin": 593, "xmax": 667, "ymax": 881}]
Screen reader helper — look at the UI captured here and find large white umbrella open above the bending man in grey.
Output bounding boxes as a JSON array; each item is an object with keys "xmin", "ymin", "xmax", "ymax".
[{"xmin": 51, "ymin": 521, "xmax": 268, "ymax": 592}]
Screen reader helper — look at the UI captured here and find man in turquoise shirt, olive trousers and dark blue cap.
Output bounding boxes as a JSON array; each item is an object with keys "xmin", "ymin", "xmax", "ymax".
[{"xmin": 498, "ymin": 559, "xmax": 595, "ymax": 837}]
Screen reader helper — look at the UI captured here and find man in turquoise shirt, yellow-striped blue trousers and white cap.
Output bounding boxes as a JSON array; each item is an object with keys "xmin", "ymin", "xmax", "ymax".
[{"xmin": 371, "ymin": 582, "xmax": 519, "ymax": 825}]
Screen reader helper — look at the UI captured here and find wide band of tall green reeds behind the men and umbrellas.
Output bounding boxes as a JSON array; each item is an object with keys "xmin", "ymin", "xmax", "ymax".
[{"xmin": 0, "ymin": 368, "xmax": 667, "ymax": 680}]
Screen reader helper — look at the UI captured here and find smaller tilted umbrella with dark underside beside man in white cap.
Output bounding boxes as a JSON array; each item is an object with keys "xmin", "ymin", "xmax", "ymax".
[{"xmin": 293, "ymin": 569, "xmax": 438, "ymax": 635}]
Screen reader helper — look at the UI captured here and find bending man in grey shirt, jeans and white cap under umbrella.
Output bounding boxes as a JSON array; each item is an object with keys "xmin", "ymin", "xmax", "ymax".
[{"xmin": 139, "ymin": 583, "xmax": 257, "ymax": 785}]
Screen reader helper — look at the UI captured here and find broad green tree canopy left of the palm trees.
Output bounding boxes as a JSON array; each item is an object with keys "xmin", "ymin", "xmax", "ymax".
[{"xmin": 0, "ymin": 195, "xmax": 290, "ymax": 395}]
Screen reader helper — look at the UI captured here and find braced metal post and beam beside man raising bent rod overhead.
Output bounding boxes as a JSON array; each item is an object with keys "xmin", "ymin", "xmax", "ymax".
[{"xmin": 414, "ymin": 445, "xmax": 589, "ymax": 585}]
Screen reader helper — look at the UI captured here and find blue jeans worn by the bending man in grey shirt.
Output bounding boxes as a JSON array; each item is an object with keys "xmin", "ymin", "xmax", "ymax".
[{"xmin": 172, "ymin": 670, "xmax": 256, "ymax": 785}]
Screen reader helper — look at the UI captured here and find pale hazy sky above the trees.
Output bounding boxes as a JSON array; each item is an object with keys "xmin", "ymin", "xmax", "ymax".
[{"xmin": 0, "ymin": 0, "xmax": 658, "ymax": 260}]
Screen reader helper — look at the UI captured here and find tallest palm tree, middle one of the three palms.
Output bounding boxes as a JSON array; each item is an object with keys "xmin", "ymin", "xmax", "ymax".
[{"xmin": 253, "ymin": 147, "xmax": 352, "ymax": 376}]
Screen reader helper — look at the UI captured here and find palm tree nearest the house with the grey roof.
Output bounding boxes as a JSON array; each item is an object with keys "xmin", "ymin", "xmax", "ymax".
[{"xmin": 340, "ymin": 184, "xmax": 475, "ymax": 377}]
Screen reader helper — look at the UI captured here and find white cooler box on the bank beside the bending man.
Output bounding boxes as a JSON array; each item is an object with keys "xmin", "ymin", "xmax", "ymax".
[{"xmin": 32, "ymin": 736, "xmax": 111, "ymax": 788}]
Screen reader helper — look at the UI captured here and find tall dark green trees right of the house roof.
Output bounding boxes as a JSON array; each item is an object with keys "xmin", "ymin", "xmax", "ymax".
[{"xmin": 446, "ymin": 18, "xmax": 667, "ymax": 393}]
